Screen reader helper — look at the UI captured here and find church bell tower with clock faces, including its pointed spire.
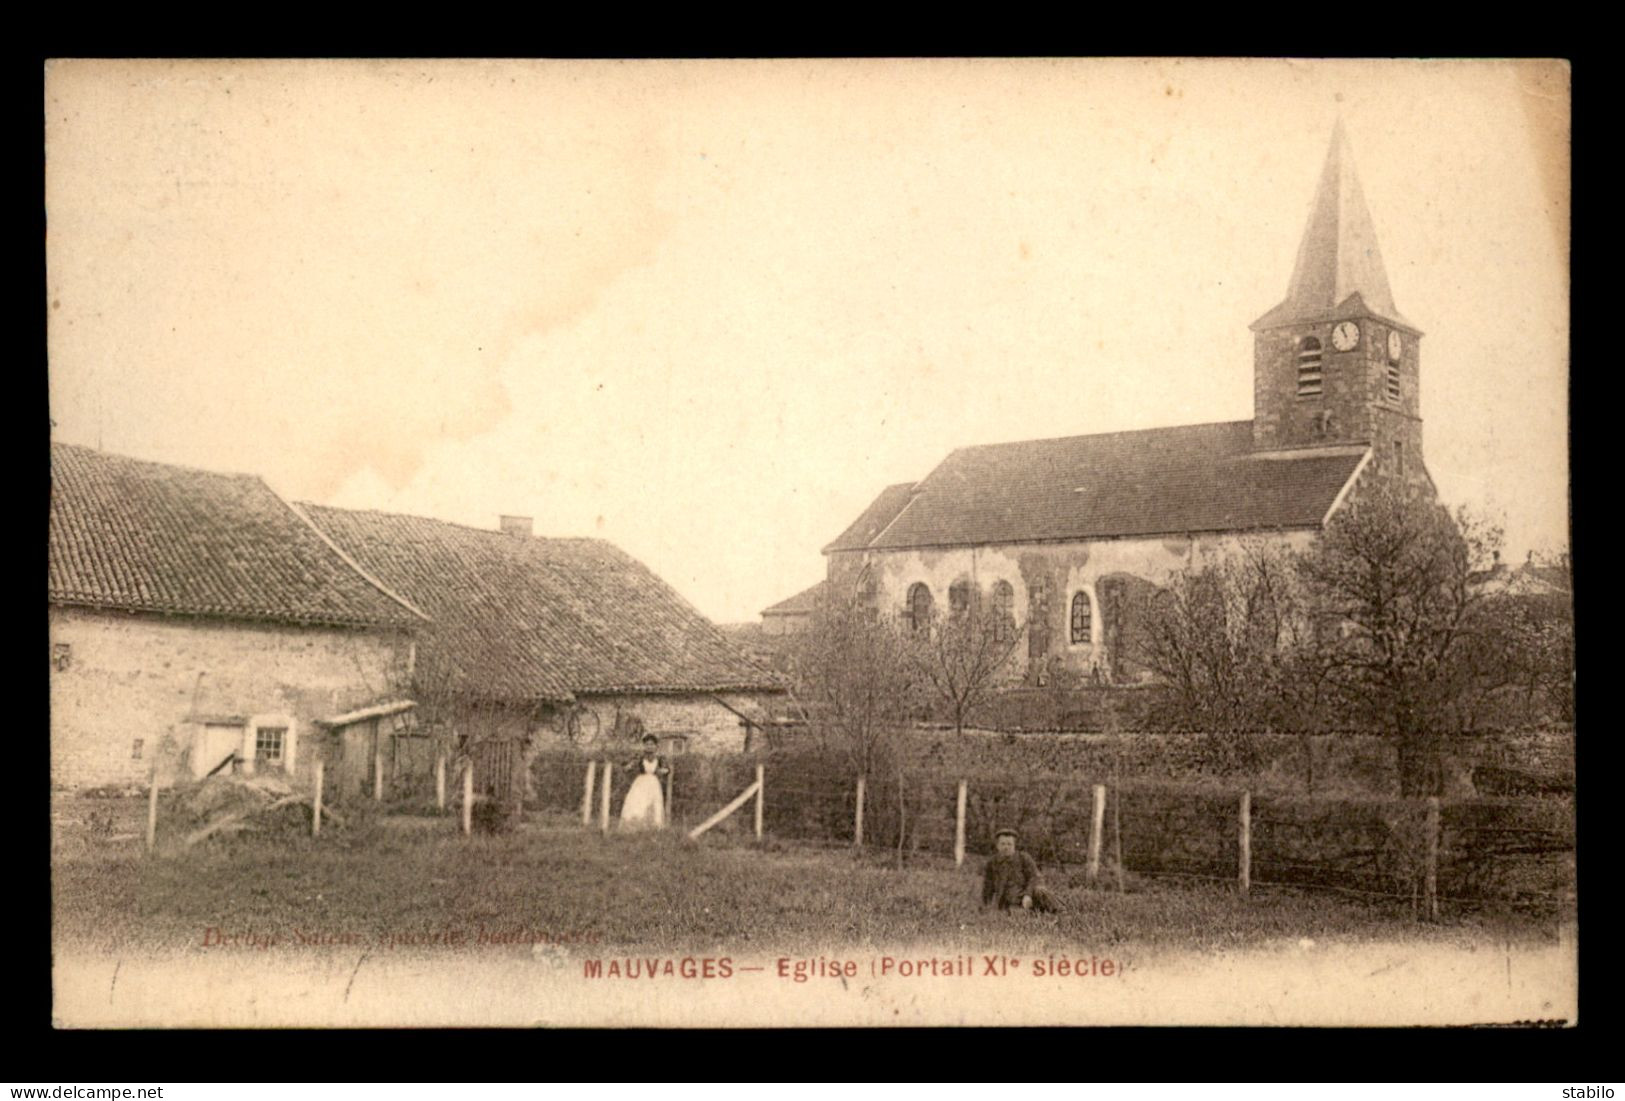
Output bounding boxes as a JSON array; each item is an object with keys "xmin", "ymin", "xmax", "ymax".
[{"xmin": 1251, "ymin": 122, "xmax": 1425, "ymax": 482}]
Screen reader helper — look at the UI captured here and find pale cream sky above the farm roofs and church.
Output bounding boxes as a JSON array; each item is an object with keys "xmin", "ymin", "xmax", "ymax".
[{"xmin": 44, "ymin": 60, "xmax": 1570, "ymax": 622}]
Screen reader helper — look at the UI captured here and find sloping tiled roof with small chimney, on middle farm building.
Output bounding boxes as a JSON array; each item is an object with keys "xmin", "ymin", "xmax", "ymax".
[{"xmin": 301, "ymin": 505, "xmax": 778, "ymax": 702}]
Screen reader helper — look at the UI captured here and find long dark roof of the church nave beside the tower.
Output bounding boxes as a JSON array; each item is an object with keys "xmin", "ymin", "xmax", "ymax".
[{"xmin": 830, "ymin": 421, "xmax": 1365, "ymax": 549}]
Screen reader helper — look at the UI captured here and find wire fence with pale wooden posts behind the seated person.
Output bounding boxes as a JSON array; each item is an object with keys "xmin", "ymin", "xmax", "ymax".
[{"xmin": 533, "ymin": 755, "xmax": 1573, "ymax": 919}]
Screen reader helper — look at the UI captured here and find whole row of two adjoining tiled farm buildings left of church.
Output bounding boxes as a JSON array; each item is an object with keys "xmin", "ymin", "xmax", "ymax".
[{"xmin": 49, "ymin": 443, "xmax": 782, "ymax": 797}]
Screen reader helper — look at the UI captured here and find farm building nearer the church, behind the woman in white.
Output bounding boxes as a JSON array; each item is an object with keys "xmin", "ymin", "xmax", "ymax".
[{"xmin": 301, "ymin": 505, "xmax": 782, "ymax": 785}]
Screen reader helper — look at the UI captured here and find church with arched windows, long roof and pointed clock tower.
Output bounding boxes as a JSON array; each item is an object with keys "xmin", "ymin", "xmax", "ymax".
[{"xmin": 824, "ymin": 122, "xmax": 1433, "ymax": 685}]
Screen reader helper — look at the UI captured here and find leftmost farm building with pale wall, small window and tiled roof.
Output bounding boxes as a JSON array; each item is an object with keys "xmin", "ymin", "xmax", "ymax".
[{"xmin": 49, "ymin": 443, "xmax": 426, "ymax": 798}]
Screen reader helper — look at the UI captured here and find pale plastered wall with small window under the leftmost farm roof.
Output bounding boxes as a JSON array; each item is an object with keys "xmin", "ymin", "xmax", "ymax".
[{"xmin": 49, "ymin": 607, "xmax": 411, "ymax": 788}]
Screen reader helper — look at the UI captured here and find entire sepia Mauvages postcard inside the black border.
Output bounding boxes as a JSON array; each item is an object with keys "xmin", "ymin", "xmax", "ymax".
[{"xmin": 44, "ymin": 58, "xmax": 1578, "ymax": 1028}]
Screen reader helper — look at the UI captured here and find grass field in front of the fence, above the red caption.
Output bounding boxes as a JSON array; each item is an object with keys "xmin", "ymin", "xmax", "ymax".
[{"xmin": 52, "ymin": 801, "xmax": 1555, "ymax": 953}]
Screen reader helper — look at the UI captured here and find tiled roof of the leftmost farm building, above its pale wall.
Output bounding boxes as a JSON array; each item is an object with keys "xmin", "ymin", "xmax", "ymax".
[{"xmin": 47, "ymin": 443, "xmax": 423, "ymax": 627}]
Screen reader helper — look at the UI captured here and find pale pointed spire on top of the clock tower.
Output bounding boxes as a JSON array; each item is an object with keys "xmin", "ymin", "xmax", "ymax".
[{"xmin": 1253, "ymin": 119, "xmax": 1411, "ymax": 331}]
